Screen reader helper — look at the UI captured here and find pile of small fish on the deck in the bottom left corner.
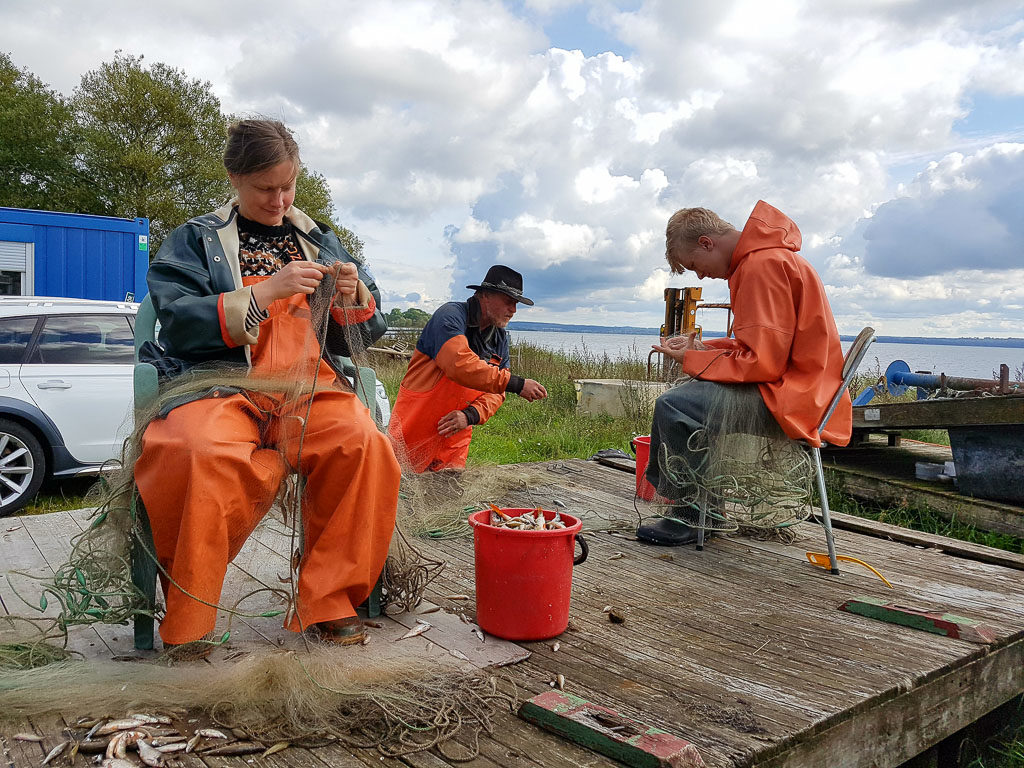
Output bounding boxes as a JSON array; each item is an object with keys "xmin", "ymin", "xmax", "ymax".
[{"xmin": 14, "ymin": 711, "xmax": 289, "ymax": 768}]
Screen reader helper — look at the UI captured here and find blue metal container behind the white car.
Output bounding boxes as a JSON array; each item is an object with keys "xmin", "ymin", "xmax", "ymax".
[{"xmin": 0, "ymin": 207, "xmax": 150, "ymax": 301}]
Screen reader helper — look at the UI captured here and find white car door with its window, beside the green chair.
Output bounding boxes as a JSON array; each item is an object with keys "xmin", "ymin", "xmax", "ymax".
[{"xmin": 22, "ymin": 314, "xmax": 134, "ymax": 464}]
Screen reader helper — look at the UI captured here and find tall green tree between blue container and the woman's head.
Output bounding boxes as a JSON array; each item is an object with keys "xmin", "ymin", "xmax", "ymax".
[{"xmin": 72, "ymin": 52, "xmax": 230, "ymax": 253}]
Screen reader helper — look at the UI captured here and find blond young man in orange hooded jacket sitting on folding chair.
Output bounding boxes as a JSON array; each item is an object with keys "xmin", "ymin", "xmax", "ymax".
[{"xmin": 637, "ymin": 201, "xmax": 852, "ymax": 546}]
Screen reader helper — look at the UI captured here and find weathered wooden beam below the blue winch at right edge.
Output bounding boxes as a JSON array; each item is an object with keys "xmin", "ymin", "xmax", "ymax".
[{"xmin": 853, "ymin": 394, "xmax": 1024, "ymax": 429}]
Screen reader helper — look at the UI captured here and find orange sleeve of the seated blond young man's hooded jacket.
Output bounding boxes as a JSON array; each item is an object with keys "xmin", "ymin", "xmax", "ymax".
[{"xmin": 683, "ymin": 265, "xmax": 797, "ymax": 384}]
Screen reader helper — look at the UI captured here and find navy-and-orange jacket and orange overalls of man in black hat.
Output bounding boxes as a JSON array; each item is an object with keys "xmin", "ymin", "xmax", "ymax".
[{"xmin": 388, "ymin": 297, "xmax": 525, "ymax": 472}]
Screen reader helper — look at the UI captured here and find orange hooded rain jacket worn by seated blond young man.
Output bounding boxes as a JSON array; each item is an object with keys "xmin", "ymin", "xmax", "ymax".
[{"xmin": 683, "ymin": 201, "xmax": 853, "ymax": 445}]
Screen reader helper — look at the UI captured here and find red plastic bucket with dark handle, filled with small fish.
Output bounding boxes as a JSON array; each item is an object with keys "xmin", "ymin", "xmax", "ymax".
[{"xmin": 469, "ymin": 509, "xmax": 588, "ymax": 640}]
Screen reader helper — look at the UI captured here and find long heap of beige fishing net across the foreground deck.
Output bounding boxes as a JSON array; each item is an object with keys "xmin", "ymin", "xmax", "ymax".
[{"xmin": 0, "ymin": 646, "xmax": 517, "ymax": 760}]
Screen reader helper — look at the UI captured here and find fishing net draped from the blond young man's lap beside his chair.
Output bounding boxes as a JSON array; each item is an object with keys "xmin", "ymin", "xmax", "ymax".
[{"xmin": 653, "ymin": 379, "xmax": 813, "ymax": 540}]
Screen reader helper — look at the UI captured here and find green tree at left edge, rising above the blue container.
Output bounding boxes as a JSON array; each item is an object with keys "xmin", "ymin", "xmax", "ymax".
[{"xmin": 0, "ymin": 53, "xmax": 95, "ymax": 212}]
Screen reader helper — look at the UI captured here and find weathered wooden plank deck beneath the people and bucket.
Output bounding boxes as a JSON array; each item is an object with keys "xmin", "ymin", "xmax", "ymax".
[{"xmin": 0, "ymin": 461, "xmax": 1024, "ymax": 768}]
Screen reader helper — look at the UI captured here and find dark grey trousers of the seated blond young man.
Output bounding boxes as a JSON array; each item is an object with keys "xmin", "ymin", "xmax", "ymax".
[{"xmin": 646, "ymin": 379, "xmax": 773, "ymax": 501}]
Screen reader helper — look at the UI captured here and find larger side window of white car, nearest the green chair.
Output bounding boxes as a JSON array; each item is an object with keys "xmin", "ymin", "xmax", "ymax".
[{"xmin": 30, "ymin": 314, "xmax": 135, "ymax": 366}]
